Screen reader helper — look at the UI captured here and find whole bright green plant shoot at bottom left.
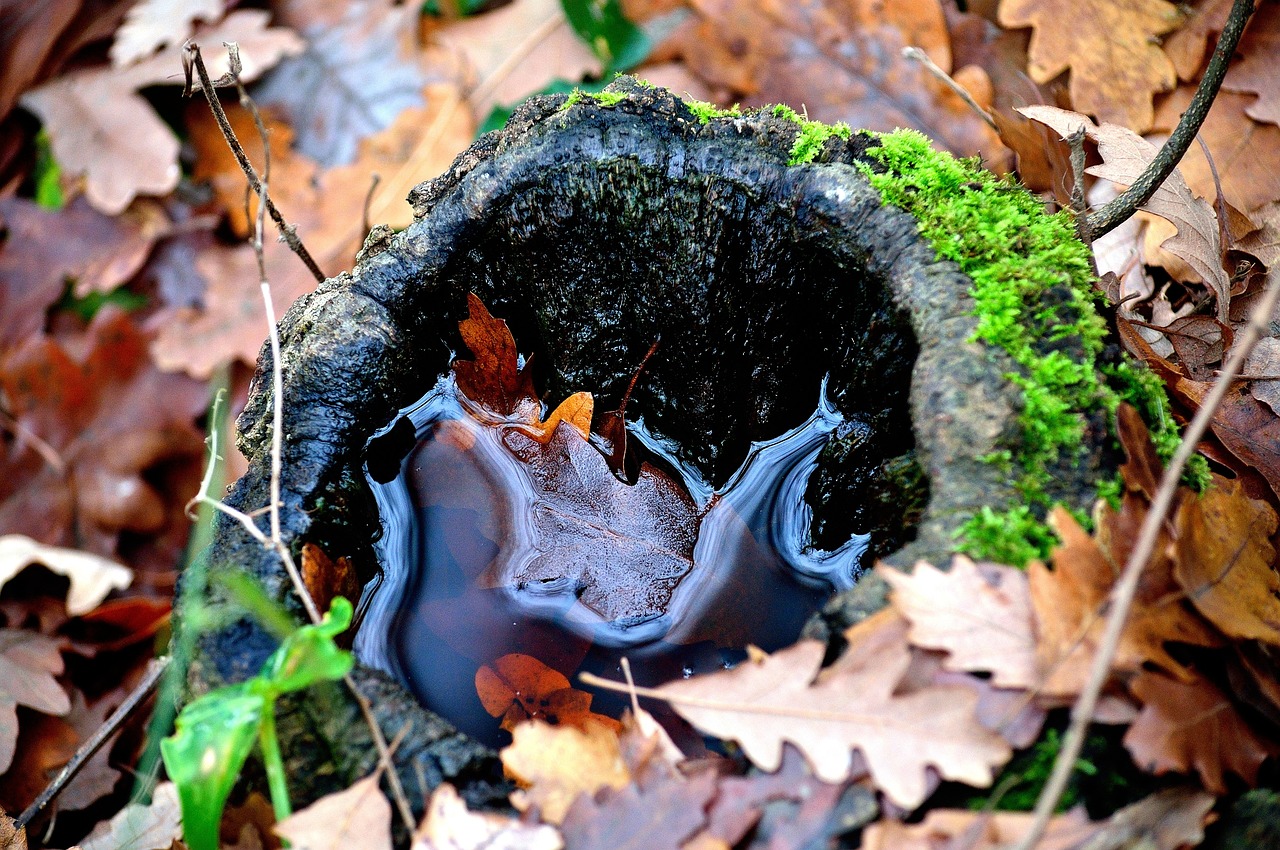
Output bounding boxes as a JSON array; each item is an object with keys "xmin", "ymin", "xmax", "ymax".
[{"xmin": 160, "ymin": 597, "xmax": 355, "ymax": 850}]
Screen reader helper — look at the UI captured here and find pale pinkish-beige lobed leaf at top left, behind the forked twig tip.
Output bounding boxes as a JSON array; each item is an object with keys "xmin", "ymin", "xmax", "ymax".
[{"xmin": 22, "ymin": 9, "xmax": 302, "ymax": 215}]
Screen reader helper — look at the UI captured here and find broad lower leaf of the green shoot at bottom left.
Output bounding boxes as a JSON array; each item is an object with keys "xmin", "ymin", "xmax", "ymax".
[{"xmin": 160, "ymin": 680, "xmax": 270, "ymax": 850}]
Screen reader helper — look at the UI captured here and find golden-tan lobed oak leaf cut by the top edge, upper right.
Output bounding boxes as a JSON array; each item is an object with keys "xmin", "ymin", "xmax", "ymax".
[{"xmin": 1000, "ymin": 0, "xmax": 1179, "ymax": 133}]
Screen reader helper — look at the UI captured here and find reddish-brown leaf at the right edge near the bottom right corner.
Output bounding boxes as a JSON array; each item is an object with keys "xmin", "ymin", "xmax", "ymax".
[{"xmin": 1124, "ymin": 671, "xmax": 1280, "ymax": 794}]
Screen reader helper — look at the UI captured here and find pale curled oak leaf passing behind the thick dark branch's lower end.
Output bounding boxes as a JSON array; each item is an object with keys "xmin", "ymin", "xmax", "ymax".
[{"xmin": 1019, "ymin": 105, "xmax": 1231, "ymax": 323}]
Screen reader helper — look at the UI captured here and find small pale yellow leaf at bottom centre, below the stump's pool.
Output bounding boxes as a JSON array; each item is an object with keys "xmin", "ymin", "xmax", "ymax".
[{"xmin": 500, "ymin": 721, "xmax": 631, "ymax": 826}]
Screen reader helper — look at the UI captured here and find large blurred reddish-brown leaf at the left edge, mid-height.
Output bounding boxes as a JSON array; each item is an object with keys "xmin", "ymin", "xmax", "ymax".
[{"xmin": 0, "ymin": 307, "xmax": 207, "ymax": 563}]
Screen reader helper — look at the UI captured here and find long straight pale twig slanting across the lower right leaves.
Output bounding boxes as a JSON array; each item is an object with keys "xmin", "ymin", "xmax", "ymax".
[{"xmin": 1016, "ymin": 270, "xmax": 1280, "ymax": 850}]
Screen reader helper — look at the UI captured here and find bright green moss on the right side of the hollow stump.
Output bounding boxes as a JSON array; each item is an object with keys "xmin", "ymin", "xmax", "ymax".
[{"xmin": 860, "ymin": 131, "xmax": 1207, "ymax": 566}]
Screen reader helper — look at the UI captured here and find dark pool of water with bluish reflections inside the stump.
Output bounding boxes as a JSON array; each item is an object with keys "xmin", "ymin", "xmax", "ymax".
[{"xmin": 356, "ymin": 378, "xmax": 867, "ymax": 745}]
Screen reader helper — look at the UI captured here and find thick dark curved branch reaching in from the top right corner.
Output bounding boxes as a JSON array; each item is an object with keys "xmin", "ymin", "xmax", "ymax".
[{"xmin": 1084, "ymin": 0, "xmax": 1253, "ymax": 242}]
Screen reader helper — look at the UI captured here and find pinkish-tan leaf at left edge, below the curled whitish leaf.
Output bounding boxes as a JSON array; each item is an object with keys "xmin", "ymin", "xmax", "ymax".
[{"xmin": 0, "ymin": 629, "xmax": 72, "ymax": 773}]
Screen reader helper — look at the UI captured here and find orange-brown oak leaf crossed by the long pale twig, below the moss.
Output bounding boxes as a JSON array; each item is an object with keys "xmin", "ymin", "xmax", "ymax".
[{"xmin": 1027, "ymin": 507, "xmax": 1217, "ymax": 696}]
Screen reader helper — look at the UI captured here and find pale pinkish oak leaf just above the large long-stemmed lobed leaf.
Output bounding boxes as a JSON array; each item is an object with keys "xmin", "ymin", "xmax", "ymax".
[{"xmin": 876, "ymin": 556, "xmax": 1039, "ymax": 689}]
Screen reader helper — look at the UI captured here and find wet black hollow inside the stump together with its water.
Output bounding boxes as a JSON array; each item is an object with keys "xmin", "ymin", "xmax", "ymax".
[{"xmin": 357, "ymin": 160, "xmax": 928, "ymax": 742}]
